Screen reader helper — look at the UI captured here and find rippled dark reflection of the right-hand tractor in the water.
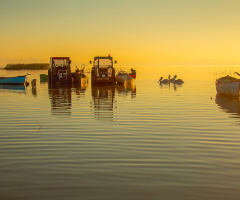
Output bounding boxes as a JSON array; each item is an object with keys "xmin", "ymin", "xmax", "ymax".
[{"xmin": 91, "ymin": 85, "xmax": 116, "ymax": 121}]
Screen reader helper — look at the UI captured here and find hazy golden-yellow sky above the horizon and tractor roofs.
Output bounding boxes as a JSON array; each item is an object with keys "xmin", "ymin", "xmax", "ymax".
[{"xmin": 0, "ymin": 0, "xmax": 240, "ymax": 65}]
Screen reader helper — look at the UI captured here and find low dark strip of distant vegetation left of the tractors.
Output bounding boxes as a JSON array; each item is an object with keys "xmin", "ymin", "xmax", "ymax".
[{"xmin": 4, "ymin": 63, "xmax": 49, "ymax": 70}]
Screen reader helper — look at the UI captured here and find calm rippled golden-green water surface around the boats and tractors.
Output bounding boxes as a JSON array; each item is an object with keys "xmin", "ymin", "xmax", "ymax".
[{"xmin": 0, "ymin": 66, "xmax": 240, "ymax": 200}]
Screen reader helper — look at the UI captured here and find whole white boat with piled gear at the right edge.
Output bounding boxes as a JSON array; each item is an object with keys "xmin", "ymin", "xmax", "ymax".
[{"xmin": 216, "ymin": 76, "xmax": 240, "ymax": 96}]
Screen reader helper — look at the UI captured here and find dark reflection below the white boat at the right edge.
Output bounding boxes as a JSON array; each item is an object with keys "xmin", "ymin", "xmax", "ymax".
[{"xmin": 215, "ymin": 94, "xmax": 240, "ymax": 118}]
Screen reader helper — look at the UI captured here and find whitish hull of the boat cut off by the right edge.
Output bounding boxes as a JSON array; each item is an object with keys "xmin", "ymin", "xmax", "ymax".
[{"xmin": 216, "ymin": 80, "xmax": 240, "ymax": 96}]
